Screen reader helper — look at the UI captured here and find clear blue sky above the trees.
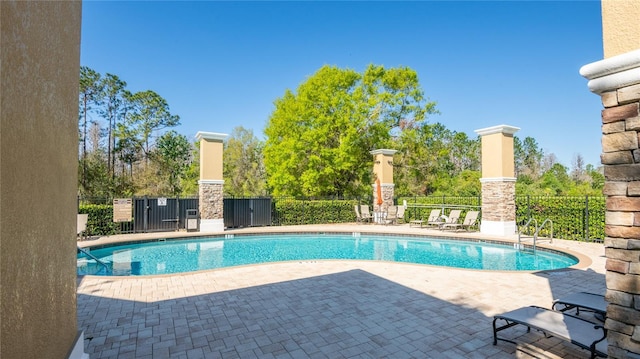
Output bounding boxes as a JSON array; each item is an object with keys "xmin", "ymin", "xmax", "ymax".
[{"xmin": 81, "ymin": 0, "xmax": 603, "ymax": 167}]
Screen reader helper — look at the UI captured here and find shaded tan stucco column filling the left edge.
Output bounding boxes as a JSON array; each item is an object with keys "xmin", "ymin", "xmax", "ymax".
[{"xmin": 0, "ymin": 0, "xmax": 88, "ymax": 359}]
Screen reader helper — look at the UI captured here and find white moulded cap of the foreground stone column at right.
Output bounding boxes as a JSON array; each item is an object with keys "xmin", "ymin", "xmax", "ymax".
[{"xmin": 580, "ymin": 49, "xmax": 640, "ymax": 95}]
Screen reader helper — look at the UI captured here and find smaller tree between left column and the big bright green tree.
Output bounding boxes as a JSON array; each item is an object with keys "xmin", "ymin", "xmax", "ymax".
[{"xmin": 223, "ymin": 127, "xmax": 266, "ymax": 197}]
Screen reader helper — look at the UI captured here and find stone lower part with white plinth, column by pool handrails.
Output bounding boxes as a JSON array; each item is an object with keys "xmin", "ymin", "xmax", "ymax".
[{"xmin": 480, "ymin": 177, "xmax": 516, "ymax": 236}]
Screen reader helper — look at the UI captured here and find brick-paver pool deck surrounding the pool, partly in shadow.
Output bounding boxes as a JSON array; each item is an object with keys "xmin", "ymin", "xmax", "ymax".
[{"xmin": 78, "ymin": 224, "xmax": 605, "ymax": 359}]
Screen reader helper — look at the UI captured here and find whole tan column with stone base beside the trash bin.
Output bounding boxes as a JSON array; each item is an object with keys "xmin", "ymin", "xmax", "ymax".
[{"xmin": 196, "ymin": 132, "xmax": 228, "ymax": 232}]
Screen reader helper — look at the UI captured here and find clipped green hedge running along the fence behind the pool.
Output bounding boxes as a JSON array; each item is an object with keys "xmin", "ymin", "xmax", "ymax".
[{"xmin": 78, "ymin": 196, "xmax": 605, "ymax": 241}]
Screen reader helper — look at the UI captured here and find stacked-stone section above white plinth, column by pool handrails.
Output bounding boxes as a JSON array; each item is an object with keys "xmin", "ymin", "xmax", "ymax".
[{"xmin": 482, "ymin": 180, "xmax": 516, "ymax": 222}]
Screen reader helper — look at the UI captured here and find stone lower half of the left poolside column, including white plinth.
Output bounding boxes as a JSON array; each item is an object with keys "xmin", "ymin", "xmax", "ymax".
[{"xmin": 198, "ymin": 181, "xmax": 224, "ymax": 232}]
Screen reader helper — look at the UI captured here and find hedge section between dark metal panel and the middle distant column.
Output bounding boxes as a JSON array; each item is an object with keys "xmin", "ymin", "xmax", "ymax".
[{"xmin": 273, "ymin": 198, "xmax": 358, "ymax": 226}]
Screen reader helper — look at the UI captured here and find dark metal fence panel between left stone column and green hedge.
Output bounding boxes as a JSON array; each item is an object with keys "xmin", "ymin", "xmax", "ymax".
[{"xmin": 222, "ymin": 198, "xmax": 273, "ymax": 228}]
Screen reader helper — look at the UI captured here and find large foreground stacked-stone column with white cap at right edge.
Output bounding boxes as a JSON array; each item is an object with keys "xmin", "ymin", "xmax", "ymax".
[{"xmin": 580, "ymin": 50, "xmax": 640, "ymax": 358}]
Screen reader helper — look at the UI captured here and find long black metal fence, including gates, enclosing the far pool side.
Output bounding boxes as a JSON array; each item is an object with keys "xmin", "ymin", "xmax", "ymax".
[{"xmin": 78, "ymin": 196, "xmax": 606, "ymax": 241}]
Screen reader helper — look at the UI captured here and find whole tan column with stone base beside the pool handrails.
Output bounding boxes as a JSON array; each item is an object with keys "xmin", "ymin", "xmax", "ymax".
[{"xmin": 475, "ymin": 125, "xmax": 519, "ymax": 236}]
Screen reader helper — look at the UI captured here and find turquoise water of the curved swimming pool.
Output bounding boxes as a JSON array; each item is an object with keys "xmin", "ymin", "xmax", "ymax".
[{"xmin": 78, "ymin": 233, "xmax": 578, "ymax": 276}]
